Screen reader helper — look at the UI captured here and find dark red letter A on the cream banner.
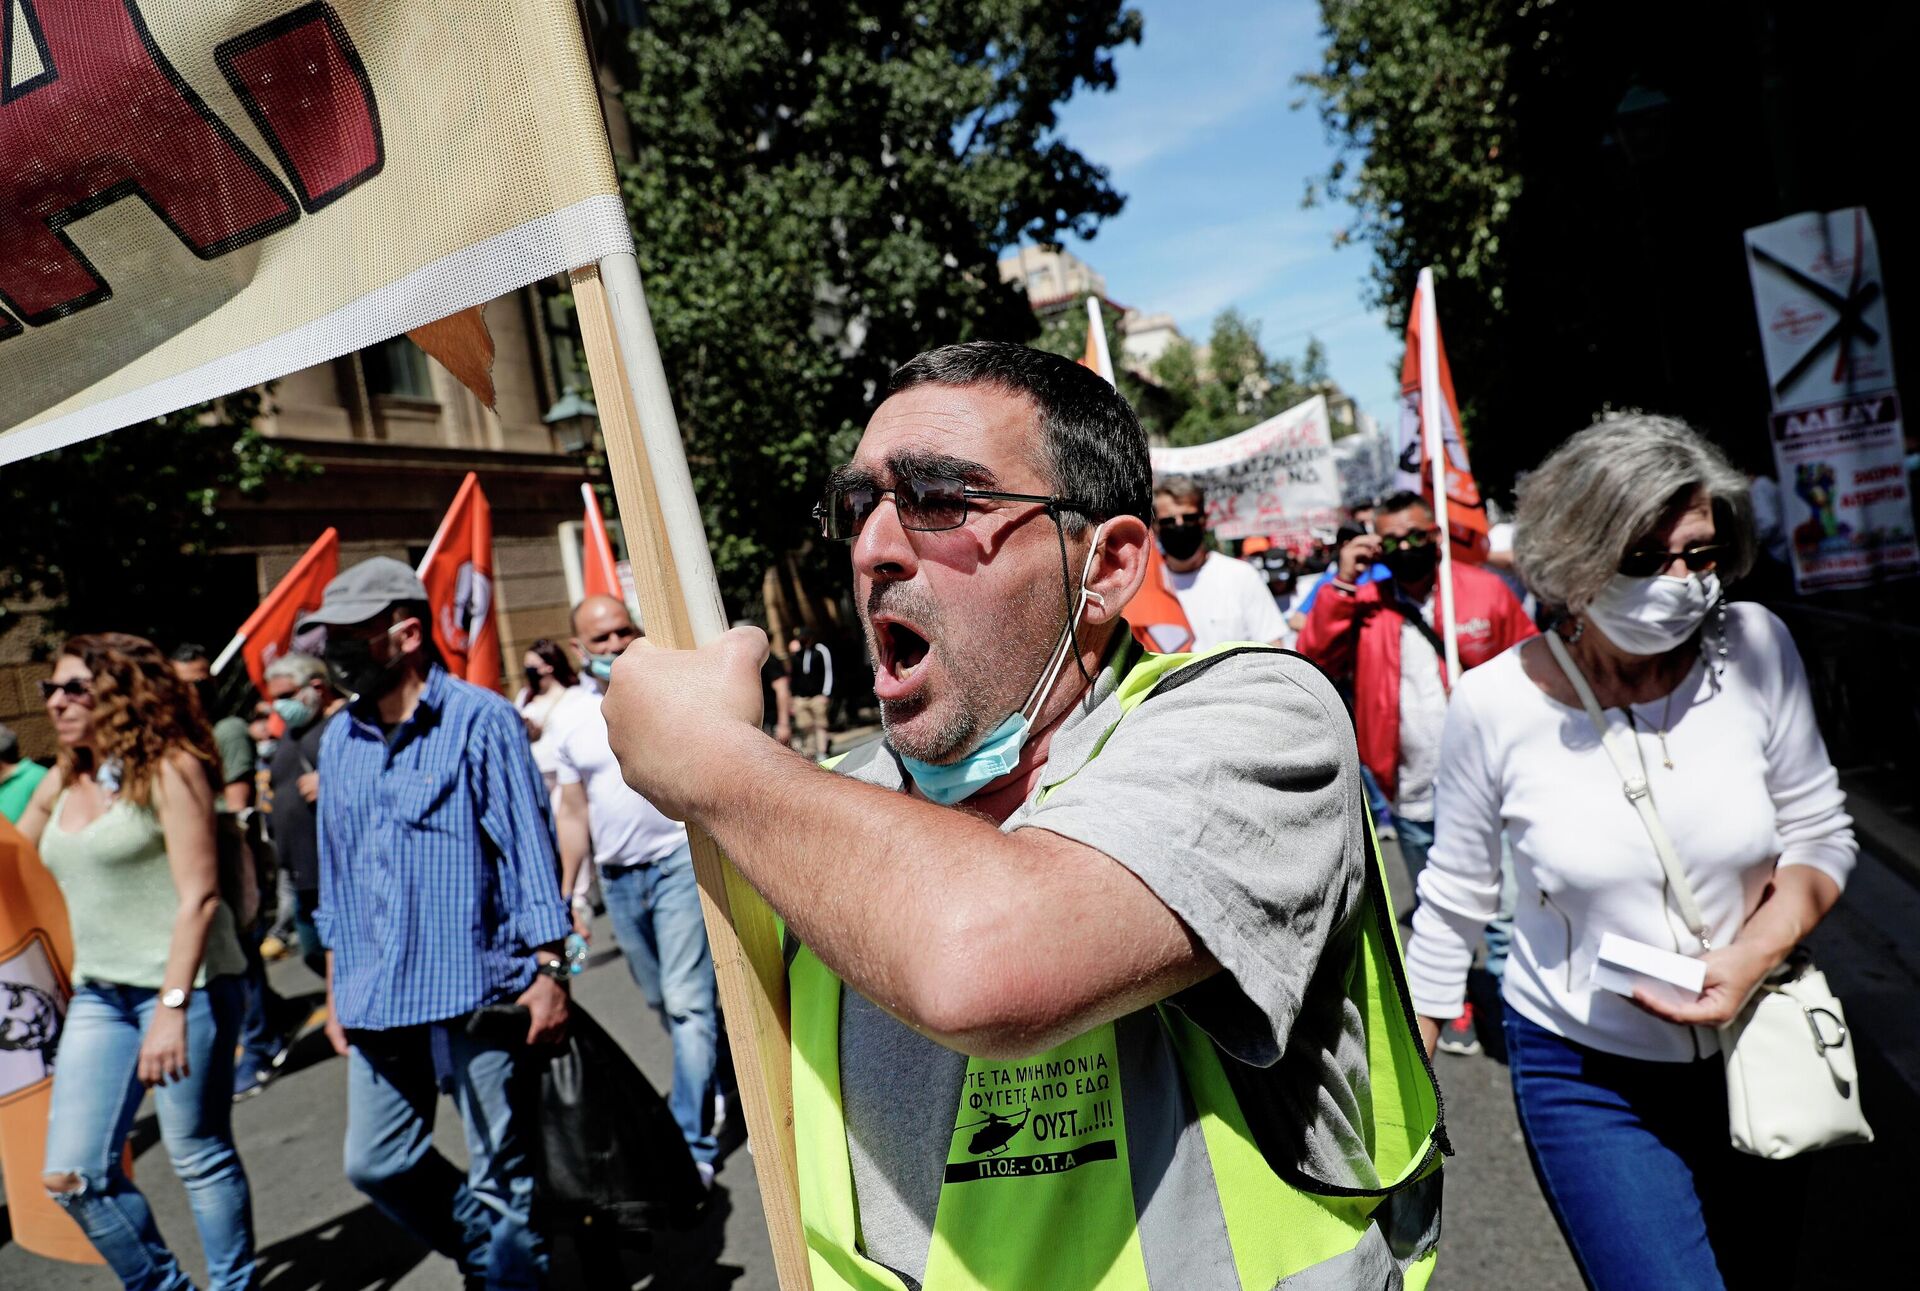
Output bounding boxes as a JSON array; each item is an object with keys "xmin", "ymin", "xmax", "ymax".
[{"xmin": 0, "ymin": 0, "xmax": 300, "ymax": 327}]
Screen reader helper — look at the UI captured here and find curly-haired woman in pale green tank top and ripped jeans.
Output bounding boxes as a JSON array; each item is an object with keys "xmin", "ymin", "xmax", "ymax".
[{"xmin": 19, "ymin": 632, "xmax": 255, "ymax": 1291}]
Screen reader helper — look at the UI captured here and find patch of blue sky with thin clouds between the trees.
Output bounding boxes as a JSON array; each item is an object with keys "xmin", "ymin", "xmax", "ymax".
[{"xmin": 1029, "ymin": 0, "xmax": 1402, "ymax": 426}]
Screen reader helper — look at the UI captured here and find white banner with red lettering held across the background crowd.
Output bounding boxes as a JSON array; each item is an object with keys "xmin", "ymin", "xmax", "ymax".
[{"xmin": 1152, "ymin": 394, "xmax": 1340, "ymax": 538}]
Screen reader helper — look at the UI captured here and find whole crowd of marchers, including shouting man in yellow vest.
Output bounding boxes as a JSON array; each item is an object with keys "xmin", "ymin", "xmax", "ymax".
[{"xmin": 0, "ymin": 342, "xmax": 1855, "ymax": 1291}]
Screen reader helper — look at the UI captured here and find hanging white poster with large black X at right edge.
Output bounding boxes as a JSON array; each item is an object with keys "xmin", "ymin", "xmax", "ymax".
[{"xmin": 1747, "ymin": 207, "xmax": 1920, "ymax": 592}]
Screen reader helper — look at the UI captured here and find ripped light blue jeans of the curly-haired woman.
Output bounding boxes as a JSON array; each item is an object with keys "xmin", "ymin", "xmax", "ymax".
[{"xmin": 46, "ymin": 976, "xmax": 255, "ymax": 1291}]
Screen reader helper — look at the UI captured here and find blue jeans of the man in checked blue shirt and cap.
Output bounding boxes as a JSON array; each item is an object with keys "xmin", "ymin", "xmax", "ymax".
[{"xmin": 346, "ymin": 1018, "xmax": 545, "ymax": 1291}]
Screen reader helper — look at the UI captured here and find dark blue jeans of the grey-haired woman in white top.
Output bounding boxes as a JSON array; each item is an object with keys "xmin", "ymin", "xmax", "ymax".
[{"xmin": 1505, "ymin": 1009, "xmax": 1807, "ymax": 1291}]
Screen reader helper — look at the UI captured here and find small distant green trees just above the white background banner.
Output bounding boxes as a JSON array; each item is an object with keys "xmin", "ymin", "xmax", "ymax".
[{"xmin": 1154, "ymin": 309, "xmax": 1327, "ymax": 448}]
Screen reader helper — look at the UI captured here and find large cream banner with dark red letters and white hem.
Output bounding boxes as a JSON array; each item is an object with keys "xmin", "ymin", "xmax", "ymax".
[{"xmin": 0, "ymin": 0, "xmax": 634, "ymax": 463}]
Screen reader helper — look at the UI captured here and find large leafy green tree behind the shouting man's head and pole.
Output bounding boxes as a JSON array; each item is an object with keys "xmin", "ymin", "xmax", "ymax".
[{"xmin": 622, "ymin": 0, "xmax": 1140, "ymax": 603}]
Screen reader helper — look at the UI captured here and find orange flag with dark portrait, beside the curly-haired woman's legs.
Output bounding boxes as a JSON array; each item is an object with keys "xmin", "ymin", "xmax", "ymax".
[{"xmin": 0, "ymin": 816, "xmax": 106, "ymax": 1264}]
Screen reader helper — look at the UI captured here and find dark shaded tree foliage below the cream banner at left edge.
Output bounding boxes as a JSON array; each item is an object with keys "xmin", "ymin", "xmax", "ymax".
[{"xmin": 0, "ymin": 390, "xmax": 311, "ymax": 649}]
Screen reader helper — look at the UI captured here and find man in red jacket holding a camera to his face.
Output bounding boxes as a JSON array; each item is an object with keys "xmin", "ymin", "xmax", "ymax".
[{"xmin": 1300, "ymin": 492, "xmax": 1536, "ymax": 882}]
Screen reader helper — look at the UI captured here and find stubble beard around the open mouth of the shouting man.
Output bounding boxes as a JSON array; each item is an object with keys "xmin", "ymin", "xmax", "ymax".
[{"xmin": 862, "ymin": 576, "xmax": 1062, "ymax": 765}]
